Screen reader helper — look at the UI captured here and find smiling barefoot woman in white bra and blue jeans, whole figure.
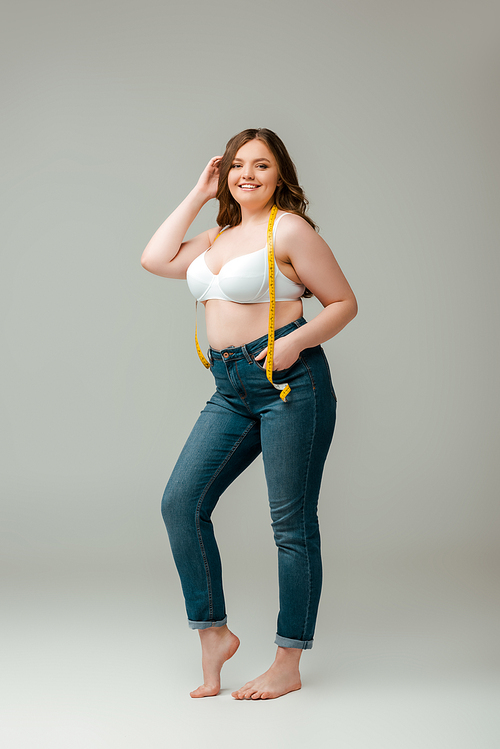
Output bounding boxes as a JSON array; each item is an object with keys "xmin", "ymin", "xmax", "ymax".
[{"xmin": 142, "ymin": 128, "xmax": 357, "ymax": 699}]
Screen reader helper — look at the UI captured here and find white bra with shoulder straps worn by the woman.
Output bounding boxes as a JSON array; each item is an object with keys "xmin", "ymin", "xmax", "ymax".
[{"xmin": 186, "ymin": 213, "xmax": 306, "ymax": 304}]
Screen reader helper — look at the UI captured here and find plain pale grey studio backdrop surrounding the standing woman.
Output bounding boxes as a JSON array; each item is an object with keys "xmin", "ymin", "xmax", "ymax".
[{"xmin": 0, "ymin": 0, "xmax": 500, "ymax": 749}]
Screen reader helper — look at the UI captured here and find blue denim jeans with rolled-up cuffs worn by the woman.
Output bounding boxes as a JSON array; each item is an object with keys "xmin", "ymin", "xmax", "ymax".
[{"xmin": 162, "ymin": 318, "xmax": 337, "ymax": 649}]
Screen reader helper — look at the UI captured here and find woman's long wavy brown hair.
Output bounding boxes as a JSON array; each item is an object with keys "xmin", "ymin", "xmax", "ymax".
[{"xmin": 216, "ymin": 127, "xmax": 318, "ymax": 298}]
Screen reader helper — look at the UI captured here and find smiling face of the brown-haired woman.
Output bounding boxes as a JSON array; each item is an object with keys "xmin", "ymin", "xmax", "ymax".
[{"xmin": 227, "ymin": 138, "xmax": 279, "ymax": 207}]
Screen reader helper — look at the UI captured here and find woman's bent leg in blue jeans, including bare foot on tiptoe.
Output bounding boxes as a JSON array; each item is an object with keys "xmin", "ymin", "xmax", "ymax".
[{"xmin": 162, "ymin": 393, "xmax": 261, "ymax": 697}]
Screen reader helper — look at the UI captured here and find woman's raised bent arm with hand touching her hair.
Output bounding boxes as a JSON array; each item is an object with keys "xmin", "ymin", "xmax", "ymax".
[{"xmin": 141, "ymin": 156, "xmax": 221, "ymax": 278}]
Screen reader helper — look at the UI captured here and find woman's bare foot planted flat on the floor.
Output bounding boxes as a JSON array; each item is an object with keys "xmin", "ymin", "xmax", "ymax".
[{"xmin": 233, "ymin": 648, "xmax": 302, "ymax": 700}]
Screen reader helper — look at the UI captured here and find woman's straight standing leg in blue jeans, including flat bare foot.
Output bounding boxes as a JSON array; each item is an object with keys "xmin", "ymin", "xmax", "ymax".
[{"xmin": 233, "ymin": 347, "xmax": 336, "ymax": 699}]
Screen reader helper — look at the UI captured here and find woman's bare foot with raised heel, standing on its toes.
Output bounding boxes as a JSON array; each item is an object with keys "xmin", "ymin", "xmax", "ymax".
[{"xmin": 190, "ymin": 624, "xmax": 240, "ymax": 697}]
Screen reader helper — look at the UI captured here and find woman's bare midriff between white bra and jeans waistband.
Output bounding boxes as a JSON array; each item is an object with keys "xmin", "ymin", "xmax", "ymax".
[{"xmin": 205, "ymin": 299, "xmax": 302, "ymax": 350}]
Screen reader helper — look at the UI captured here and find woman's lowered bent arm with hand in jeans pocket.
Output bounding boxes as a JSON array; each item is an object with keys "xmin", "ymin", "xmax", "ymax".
[{"xmin": 264, "ymin": 216, "xmax": 358, "ymax": 370}]
